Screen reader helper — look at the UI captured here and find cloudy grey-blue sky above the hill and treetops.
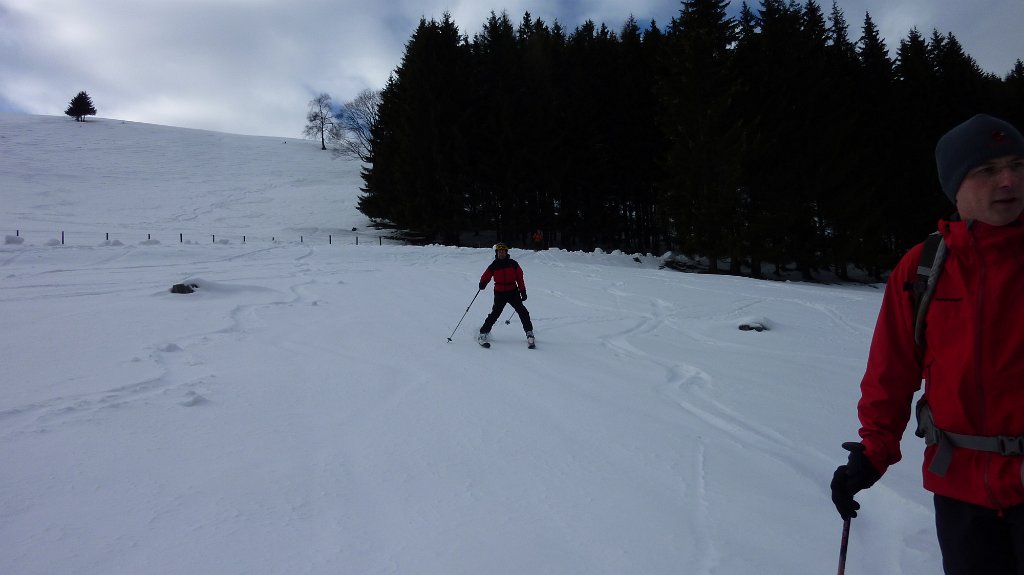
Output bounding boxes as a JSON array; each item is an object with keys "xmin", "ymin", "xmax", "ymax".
[{"xmin": 0, "ymin": 0, "xmax": 1024, "ymax": 137}]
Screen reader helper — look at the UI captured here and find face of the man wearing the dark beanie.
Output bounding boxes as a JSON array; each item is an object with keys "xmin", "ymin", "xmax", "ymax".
[{"xmin": 956, "ymin": 156, "xmax": 1024, "ymax": 226}]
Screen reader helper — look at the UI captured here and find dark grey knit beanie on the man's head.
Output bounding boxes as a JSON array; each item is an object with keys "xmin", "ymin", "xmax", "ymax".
[{"xmin": 935, "ymin": 114, "xmax": 1024, "ymax": 203}]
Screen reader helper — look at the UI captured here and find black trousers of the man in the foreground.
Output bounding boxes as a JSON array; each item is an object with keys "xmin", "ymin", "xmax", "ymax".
[{"xmin": 935, "ymin": 495, "xmax": 1024, "ymax": 575}]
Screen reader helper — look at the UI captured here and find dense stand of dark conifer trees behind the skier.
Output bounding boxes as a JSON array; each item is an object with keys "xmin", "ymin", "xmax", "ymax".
[{"xmin": 359, "ymin": 0, "xmax": 1024, "ymax": 279}]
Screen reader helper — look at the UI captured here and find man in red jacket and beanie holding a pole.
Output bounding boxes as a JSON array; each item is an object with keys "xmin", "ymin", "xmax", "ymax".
[{"xmin": 831, "ymin": 115, "xmax": 1024, "ymax": 575}]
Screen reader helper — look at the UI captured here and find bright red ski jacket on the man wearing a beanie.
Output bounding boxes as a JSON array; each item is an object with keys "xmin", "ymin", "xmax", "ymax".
[{"xmin": 857, "ymin": 217, "xmax": 1024, "ymax": 510}]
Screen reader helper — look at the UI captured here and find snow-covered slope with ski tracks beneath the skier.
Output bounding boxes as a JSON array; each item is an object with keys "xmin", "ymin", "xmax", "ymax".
[{"xmin": 0, "ymin": 115, "xmax": 941, "ymax": 575}]
